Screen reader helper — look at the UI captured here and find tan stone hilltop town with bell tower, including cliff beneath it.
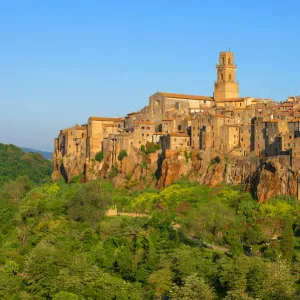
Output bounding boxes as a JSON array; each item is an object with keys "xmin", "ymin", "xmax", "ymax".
[{"xmin": 53, "ymin": 52, "xmax": 300, "ymax": 201}]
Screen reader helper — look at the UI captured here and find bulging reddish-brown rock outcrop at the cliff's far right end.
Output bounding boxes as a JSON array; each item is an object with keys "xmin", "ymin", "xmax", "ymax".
[{"xmin": 250, "ymin": 157, "xmax": 297, "ymax": 202}]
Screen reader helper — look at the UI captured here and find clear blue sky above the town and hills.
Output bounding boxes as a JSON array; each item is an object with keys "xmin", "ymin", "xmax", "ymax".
[{"xmin": 0, "ymin": 0, "xmax": 300, "ymax": 151}]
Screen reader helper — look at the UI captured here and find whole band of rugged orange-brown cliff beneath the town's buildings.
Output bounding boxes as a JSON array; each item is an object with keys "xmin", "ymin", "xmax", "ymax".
[{"xmin": 53, "ymin": 144, "xmax": 297, "ymax": 202}]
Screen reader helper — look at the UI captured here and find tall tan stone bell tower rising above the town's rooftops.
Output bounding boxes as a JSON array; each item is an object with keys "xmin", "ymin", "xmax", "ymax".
[{"xmin": 214, "ymin": 52, "xmax": 239, "ymax": 102}]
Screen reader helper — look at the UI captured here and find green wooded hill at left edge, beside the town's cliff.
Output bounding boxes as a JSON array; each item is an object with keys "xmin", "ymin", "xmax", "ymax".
[{"xmin": 0, "ymin": 143, "xmax": 52, "ymax": 187}]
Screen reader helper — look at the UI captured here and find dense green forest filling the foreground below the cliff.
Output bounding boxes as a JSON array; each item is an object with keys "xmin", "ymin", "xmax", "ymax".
[{"xmin": 0, "ymin": 145, "xmax": 300, "ymax": 300}]
